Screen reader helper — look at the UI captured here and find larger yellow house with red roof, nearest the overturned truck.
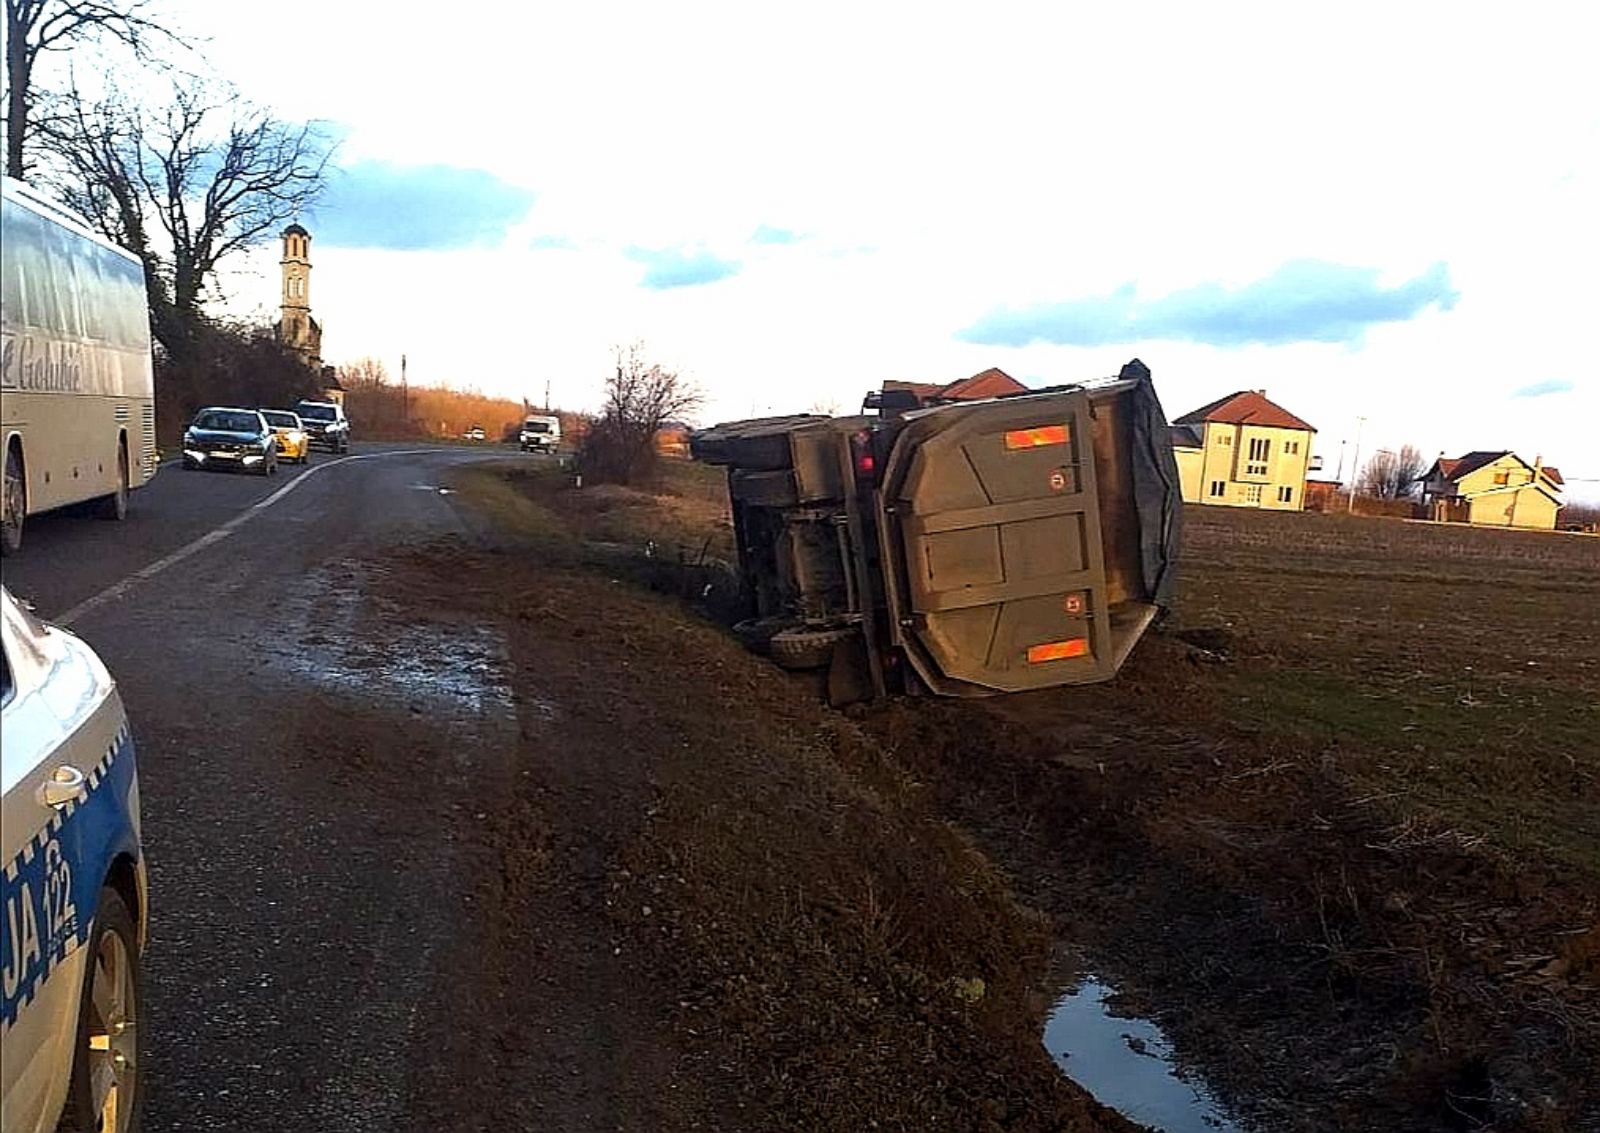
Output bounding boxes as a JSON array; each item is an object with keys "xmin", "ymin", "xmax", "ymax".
[{"xmin": 1173, "ymin": 389, "xmax": 1317, "ymax": 512}]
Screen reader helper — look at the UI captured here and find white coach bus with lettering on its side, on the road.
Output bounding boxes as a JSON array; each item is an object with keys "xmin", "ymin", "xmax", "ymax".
[{"xmin": 0, "ymin": 178, "xmax": 155, "ymax": 552}]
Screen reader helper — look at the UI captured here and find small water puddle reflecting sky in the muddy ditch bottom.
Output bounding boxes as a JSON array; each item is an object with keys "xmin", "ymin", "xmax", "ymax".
[{"xmin": 1045, "ymin": 978, "xmax": 1242, "ymax": 1133}]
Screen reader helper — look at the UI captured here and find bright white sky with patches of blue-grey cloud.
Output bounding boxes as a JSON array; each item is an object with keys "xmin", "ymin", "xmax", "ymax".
[{"xmin": 159, "ymin": 0, "xmax": 1600, "ymax": 499}]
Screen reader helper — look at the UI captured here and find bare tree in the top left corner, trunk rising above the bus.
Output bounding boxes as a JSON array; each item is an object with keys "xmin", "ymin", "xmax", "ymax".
[{"xmin": 5, "ymin": 0, "xmax": 178, "ymax": 178}]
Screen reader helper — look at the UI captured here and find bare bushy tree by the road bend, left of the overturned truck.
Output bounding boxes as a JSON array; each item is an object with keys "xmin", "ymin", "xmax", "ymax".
[{"xmin": 579, "ymin": 342, "xmax": 702, "ymax": 483}]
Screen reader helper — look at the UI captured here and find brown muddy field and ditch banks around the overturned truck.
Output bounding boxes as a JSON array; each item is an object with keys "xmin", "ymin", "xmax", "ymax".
[{"xmin": 438, "ymin": 470, "xmax": 1600, "ymax": 1130}]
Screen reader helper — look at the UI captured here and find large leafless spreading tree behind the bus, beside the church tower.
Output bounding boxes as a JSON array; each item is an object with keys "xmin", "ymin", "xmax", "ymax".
[{"xmin": 40, "ymin": 85, "xmax": 328, "ymax": 352}]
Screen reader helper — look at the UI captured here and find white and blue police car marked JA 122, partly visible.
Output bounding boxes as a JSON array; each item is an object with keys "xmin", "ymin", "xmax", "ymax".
[{"xmin": 0, "ymin": 587, "xmax": 146, "ymax": 1133}]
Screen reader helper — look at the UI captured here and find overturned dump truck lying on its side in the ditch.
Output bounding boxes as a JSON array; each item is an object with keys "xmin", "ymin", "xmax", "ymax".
[{"xmin": 690, "ymin": 360, "xmax": 1182, "ymax": 703}]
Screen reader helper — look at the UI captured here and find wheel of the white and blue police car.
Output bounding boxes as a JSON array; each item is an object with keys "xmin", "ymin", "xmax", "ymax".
[{"xmin": 56, "ymin": 887, "xmax": 144, "ymax": 1133}]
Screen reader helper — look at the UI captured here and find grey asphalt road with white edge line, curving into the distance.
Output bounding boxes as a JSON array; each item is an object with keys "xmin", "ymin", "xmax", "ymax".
[{"xmin": 5, "ymin": 446, "xmax": 534, "ymax": 1131}]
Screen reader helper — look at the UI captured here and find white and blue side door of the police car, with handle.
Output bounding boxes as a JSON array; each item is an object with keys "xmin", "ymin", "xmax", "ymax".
[{"xmin": 0, "ymin": 597, "xmax": 86, "ymax": 1133}]
